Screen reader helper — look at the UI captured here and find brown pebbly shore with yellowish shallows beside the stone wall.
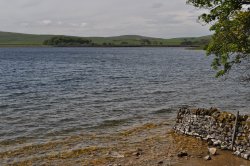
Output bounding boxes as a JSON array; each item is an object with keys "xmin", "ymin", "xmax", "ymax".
[{"xmin": 0, "ymin": 121, "xmax": 249, "ymax": 166}]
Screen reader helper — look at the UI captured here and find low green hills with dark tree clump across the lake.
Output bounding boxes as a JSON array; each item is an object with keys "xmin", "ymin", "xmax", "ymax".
[{"xmin": 0, "ymin": 32, "xmax": 210, "ymax": 47}]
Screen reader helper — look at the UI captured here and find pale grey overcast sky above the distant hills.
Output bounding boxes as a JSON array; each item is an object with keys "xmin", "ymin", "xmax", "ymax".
[{"xmin": 0, "ymin": 0, "xmax": 210, "ymax": 38}]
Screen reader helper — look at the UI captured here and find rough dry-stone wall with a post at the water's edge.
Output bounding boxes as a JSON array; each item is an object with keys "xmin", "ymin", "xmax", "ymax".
[{"xmin": 174, "ymin": 108, "xmax": 250, "ymax": 160}]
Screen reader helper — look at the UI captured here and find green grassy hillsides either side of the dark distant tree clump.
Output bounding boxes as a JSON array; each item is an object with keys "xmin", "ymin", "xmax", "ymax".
[{"xmin": 0, "ymin": 32, "xmax": 210, "ymax": 47}]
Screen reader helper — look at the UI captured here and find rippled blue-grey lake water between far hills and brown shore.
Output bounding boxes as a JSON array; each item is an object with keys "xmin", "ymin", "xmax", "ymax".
[{"xmin": 0, "ymin": 48, "xmax": 250, "ymax": 151}]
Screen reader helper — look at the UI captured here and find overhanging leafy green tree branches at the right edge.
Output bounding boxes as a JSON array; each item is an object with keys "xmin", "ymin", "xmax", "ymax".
[{"xmin": 187, "ymin": 0, "xmax": 250, "ymax": 77}]
